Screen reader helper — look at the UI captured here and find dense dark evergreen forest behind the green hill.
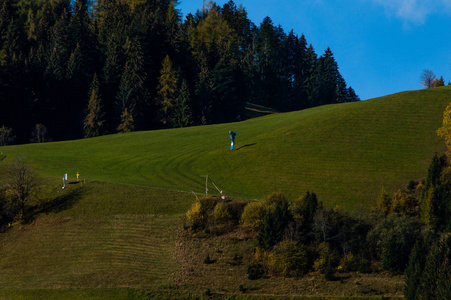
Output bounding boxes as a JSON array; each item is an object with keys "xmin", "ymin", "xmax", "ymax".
[{"xmin": 0, "ymin": 0, "xmax": 359, "ymax": 144}]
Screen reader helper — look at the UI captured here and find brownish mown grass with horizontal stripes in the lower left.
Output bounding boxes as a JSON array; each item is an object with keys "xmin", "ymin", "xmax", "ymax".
[{"xmin": 0, "ymin": 214, "xmax": 179, "ymax": 289}]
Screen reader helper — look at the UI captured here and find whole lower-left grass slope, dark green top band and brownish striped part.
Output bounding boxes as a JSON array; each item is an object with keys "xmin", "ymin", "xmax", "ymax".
[{"xmin": 0, "ymin": 183, "xmax": 195, "ymax": 290}]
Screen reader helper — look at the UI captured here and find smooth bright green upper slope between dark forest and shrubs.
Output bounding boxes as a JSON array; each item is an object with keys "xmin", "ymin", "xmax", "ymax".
[{"xmin": 1, "ymin": 87, "xmax": 451, "ymax": 209}]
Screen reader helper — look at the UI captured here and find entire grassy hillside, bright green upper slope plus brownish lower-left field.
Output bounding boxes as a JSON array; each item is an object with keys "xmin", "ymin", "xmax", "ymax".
[{"xmin": 0, "ymin": 87, "xmax": 451, "ymax": 299}]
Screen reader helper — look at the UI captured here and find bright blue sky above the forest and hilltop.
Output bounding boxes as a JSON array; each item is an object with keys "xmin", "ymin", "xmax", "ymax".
[{"xmin": 177, "ymin": 0, "xmax": 451, "ymax": 100}]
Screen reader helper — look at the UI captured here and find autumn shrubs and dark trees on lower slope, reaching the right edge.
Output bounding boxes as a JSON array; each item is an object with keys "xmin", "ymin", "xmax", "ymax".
[{"xmin": 187, "ymin": 155, "xmax": 451, "ymax": 299}]
